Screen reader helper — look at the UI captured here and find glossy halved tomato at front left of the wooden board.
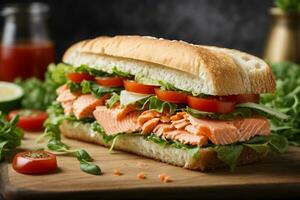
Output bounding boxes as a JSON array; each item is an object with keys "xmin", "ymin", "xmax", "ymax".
[{"xmin": 12, "ymin": 150, "xmax": 57, "ymax": 174}]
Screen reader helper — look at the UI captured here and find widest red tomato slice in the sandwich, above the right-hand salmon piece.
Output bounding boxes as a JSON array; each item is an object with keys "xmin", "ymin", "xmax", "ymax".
[{"xmin": 187, "ymin": 96, "xmax": 235, "ymax": 113}]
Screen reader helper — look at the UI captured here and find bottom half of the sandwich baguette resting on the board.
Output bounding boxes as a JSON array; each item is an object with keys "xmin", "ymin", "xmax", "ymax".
[{"xmin": 60, "ymin": 121, "xmax": 268, "ymax": 171}]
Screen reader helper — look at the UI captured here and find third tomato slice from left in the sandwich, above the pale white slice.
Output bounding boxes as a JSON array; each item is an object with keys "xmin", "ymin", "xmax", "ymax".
[{"xmin": 123, "ymin": 80, "xmax": 156, "ymax": 94}]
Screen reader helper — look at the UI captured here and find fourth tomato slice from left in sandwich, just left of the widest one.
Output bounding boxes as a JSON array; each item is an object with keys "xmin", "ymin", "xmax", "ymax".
[{"xmin": 155, "ymin": 88, "xmax": 187, "ymax": 103}]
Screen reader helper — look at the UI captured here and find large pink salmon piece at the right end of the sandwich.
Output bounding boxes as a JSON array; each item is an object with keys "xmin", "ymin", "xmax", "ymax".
[{"xmin": 186, "ymin": 115, "xmax": 271, "ymax": 145}]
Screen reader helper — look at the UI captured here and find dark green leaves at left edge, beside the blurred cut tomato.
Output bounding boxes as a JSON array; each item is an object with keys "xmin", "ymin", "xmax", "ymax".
[{"xmin": 0, "ymin": 111, "xmax": 23, "ymax": 161}]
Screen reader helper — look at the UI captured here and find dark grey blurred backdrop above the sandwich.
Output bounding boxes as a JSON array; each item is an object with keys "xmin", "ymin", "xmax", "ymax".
[{"xmin": 0, "ymin": 0, "xmax": 273, "ymax": 60}]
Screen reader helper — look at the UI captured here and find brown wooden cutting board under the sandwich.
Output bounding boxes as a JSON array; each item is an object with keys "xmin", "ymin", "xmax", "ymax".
[{"xmin": 0, "ymin": 134, "xmax": 300, "ymax": 200}]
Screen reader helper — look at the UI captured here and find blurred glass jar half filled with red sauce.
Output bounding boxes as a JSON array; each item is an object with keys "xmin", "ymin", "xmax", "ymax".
[{"xmin": 0, "ymin": 3, "xmax": 55, "ymax": 81}]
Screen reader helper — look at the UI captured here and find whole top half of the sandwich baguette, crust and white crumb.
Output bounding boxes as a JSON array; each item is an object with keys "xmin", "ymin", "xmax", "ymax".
[{"xmin": 63, "ymin": 36, "xmax": 276, "ymax": 95}]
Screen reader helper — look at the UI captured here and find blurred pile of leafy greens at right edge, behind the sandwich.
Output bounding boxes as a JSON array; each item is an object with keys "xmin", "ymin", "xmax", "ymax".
[{"xmin": 260, "ymin": 62, "xmax": 300, "ymax": 146}]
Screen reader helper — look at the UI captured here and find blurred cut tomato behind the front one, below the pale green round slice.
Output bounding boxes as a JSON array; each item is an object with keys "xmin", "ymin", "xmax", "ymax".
[{"xmin": 8, "ymin": 109, "xmax": 48, "ymax": 132}]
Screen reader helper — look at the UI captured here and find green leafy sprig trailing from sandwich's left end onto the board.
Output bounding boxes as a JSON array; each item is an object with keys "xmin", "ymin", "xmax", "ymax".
[{"xmin": 39, "ymin": 102, "xmax": 101, "ymax": 175}]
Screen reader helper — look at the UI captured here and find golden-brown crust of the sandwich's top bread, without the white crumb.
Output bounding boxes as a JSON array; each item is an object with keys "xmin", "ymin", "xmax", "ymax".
[{"xmin": 63, "ymin": 36, "xmax": 275, "ymax": 95}]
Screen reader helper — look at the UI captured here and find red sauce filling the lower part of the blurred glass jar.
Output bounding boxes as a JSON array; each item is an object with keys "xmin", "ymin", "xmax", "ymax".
[{"xmin": 0, "ymin": 42, "xmax": 55, "ymax": 81}]
